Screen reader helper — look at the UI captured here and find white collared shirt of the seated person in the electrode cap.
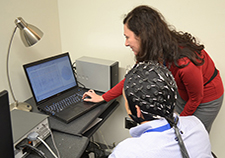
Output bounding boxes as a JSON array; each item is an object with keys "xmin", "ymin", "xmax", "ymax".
[{"xmin": 109, "ymin": 116, "xmax": 213, "ymax": 158}]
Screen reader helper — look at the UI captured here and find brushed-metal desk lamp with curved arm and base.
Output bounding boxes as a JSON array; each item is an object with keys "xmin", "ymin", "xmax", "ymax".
[{"xmin": 6, "ymin": 17, "xmax": 43, "ymax": 111}]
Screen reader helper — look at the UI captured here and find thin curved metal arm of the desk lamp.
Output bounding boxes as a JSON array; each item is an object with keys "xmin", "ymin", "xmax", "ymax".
[{"xmin": 6, "ymin": 26, "xmax": 18, "ymax": 105}]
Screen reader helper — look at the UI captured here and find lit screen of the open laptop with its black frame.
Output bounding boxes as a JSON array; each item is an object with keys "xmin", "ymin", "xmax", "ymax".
[{"xmin": 24, "ymin": 53, "xmax": 77, "ymax": 102}]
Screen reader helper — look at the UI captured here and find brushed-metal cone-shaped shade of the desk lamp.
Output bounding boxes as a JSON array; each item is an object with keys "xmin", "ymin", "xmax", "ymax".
[{"xmin": 15, "ymin": 17, "xmax": 43, "ymax": 47}]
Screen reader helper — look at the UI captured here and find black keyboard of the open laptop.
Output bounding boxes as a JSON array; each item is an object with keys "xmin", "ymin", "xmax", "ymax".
[{"xmin": 45, "ymin": 91, "xmax": 83, "ymax": 115}]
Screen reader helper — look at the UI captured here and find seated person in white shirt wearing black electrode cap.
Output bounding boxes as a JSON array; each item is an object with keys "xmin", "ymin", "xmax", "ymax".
[{"xmin": 109, "ymin": 62, "xmax": 213, "ymax": 158}]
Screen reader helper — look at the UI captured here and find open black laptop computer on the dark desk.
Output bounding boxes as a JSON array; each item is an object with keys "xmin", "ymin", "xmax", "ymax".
[{"xmin": 23, "ymin": 52, "xmax": 100, "ymax": 123}]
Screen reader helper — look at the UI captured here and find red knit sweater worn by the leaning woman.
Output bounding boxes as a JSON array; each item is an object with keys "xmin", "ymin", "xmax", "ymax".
[{"xmin": 102, "ymin": 50, "xmax": 224, "ymax": 116}]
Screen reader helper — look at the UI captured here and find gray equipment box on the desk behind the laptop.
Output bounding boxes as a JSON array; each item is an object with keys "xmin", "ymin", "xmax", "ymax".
[{"xmin": 76, "ymin": 56, "xmax": 119, "ymax": 92}]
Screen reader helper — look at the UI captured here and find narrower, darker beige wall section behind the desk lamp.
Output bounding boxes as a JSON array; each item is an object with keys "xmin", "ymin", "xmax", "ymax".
[{"xmin": 0, "ymin": 0, "xmax": 61, "ymax": 102}]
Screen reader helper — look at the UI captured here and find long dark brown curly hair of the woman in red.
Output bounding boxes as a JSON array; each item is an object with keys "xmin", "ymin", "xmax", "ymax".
[{"xmin": 123, "ymin": 5, "xmax": 204, "ymax": 67}]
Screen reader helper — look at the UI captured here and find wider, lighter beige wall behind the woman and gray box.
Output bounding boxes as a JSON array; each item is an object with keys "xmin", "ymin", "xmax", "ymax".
[{"xmin": 58, "ymin": 0, "xmax": 225, "ymax": 157}]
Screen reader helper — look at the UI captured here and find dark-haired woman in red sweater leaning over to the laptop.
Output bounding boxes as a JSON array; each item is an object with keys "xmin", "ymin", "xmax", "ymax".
[{"xmin": 84, "ymin": 6, "xmax": 224, "ymax": 132}]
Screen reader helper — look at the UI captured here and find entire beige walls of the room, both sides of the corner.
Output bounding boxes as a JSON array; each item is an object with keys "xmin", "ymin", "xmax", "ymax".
[{"xmin": 0, "ymin": 0, "xmax": 225, "ymax": 157}]
